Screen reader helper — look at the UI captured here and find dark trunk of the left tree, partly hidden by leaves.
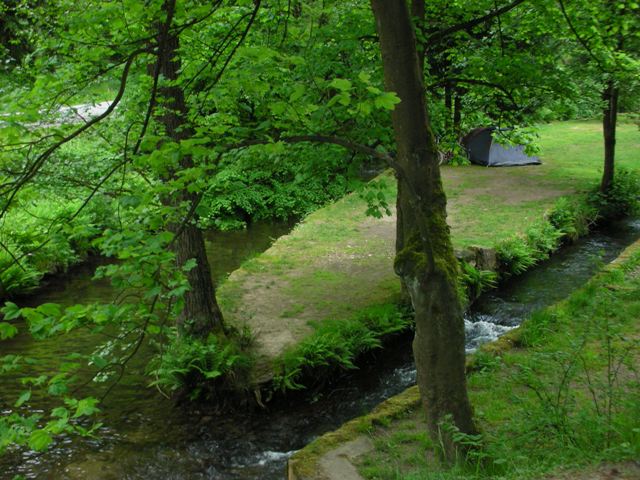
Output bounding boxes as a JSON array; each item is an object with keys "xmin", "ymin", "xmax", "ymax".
[{"xmin": 156, "ymin": 0, "xmax": 223, "ymax": 337}]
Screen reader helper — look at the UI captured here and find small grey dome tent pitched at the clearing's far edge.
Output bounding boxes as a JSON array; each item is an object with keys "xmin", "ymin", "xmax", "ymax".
[{"xmin": 462, "ymin": 127, "xmax": 541, "ymax": 167}]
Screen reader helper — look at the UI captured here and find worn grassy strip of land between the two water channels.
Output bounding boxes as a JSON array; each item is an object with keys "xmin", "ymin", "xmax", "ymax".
[{"xmin": 219, "ymin": 122, "xmax": 638, "ymax": 382}]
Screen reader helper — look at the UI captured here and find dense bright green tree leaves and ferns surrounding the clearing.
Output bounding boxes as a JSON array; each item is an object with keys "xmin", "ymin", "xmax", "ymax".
[{"xmin": 0, "ymin": 0, "xmax": 640, "ymax": 468}]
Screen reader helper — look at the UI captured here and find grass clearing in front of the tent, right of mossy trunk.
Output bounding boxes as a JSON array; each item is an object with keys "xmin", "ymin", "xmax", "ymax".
[{"xmin": 444, "ymin": 117, "xmax": 640, "ymax": 248}]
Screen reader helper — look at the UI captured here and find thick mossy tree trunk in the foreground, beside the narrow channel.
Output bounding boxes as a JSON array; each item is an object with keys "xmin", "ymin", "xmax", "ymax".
[{"xmin": 371, "ymin": 0, "xmax": 476, "ymax": 459}]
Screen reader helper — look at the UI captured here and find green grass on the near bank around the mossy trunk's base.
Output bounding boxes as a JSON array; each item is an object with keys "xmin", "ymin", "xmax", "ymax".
[{"xmin": 360, "ymin": 242, "xmax": 640, "ymax": 480}]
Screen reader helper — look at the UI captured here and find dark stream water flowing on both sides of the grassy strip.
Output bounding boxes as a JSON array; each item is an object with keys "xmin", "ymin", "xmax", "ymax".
[{"xmin": 0, "ymin": 221, "xmax": 640, "ymax": 480}]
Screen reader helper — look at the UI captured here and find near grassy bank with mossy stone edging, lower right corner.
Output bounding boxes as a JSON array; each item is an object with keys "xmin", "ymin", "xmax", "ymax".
[{"xmin": 288, "ymin": 234, "xmax": 640, "ymax": 480}]
